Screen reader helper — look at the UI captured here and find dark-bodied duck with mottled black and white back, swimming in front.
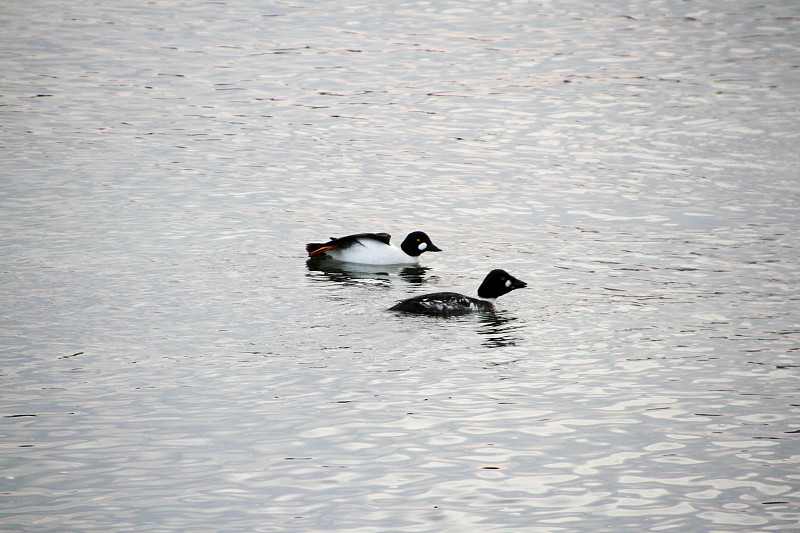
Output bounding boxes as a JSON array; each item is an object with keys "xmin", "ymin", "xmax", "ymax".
[{"xmin": 389, "ymin": 268, "xmax": 528, "ymax": 316}]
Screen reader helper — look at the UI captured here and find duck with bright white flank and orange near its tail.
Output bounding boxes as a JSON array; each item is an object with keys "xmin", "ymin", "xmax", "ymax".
[{"xmin": 306, "ymin": 231, "xmax": 442, "ymax": 265}]
